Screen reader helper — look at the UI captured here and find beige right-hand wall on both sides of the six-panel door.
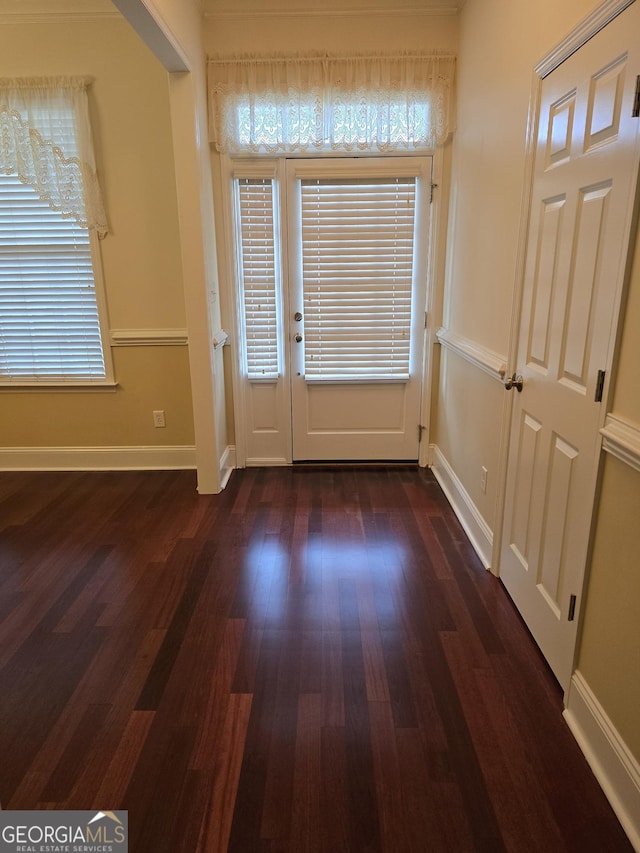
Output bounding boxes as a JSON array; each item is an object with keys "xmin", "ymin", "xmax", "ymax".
[{"xmin": 444, "ymin": 0, "xmax": 640, "ymax": 760}]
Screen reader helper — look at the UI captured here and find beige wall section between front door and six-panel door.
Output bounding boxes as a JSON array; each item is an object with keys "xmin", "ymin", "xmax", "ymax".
[{"xmin": 433, "ymin": 0, "xmax": 594, "ymax": 530}]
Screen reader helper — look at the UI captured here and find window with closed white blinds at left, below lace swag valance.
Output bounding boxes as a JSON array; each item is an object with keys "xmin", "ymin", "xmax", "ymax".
[{"xmin": 0, "ymin": 175, "xmax": 106, "ymax": 384}]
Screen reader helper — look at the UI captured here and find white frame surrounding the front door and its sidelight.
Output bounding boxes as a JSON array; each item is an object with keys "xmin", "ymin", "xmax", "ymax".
[{"xmin": 222, "ymin": 147, "xmax": 449, "ymax": 468}]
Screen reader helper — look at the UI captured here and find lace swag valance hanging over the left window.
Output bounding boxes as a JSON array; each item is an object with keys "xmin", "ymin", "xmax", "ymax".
[{"xmin": 0, "ymin": 77, "xmax": 108, "ymax": 237}]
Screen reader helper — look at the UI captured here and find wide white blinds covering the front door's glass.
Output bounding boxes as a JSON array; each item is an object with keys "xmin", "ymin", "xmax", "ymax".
[{"xmin": 300, "ymin": 177, "xmax": 416, "ymax": 381}]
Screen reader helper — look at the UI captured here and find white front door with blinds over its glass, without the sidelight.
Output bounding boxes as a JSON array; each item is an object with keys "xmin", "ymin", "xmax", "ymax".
[{"xmin": 285, "ymin": 157, "xmax": 431, "ymax": 461}]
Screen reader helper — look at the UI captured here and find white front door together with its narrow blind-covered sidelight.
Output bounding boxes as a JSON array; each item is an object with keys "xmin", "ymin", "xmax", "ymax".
[{"xmin": 233, "ymin": 157, "xmax": 432, "ymax": 465}]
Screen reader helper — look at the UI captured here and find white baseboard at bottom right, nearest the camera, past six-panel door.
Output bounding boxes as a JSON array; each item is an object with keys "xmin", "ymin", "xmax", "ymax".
[{"xmin": 564, "ymin": 671, "xmax": 640, "ymax": 853}]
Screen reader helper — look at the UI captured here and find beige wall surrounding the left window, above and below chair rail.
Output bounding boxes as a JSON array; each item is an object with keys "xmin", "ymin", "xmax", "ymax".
[{"xmin": 0, "ymin": 14, "xmax": 194, "ymax": 447}]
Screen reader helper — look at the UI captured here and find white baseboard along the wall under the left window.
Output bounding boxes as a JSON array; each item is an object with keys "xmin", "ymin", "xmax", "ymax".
[{"xmin": 0, "ymin": 446, "xmax": 196, "ymax": 471}]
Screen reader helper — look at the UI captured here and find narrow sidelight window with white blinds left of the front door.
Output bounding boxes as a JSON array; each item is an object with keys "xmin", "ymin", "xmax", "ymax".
[{"xmin": 236, "ymin": 178, "xmax": 280, "ymax": 380}]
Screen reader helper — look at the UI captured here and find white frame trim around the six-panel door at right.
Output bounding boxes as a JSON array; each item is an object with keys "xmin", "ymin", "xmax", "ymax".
[{"xmin": 491, "ymin": 0, "xmax": 636, "ymax": 576}]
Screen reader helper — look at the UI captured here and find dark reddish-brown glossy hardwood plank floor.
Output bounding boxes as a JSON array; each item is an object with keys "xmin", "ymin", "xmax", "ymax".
[{"xmin": 0, "ymin": 467, "xmax": 631, "ymax": 853}]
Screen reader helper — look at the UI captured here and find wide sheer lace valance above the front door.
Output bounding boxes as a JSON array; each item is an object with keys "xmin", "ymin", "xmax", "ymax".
[{"xmin": 208, "ymin": 53, "xmax": 455, "ymax": 153}]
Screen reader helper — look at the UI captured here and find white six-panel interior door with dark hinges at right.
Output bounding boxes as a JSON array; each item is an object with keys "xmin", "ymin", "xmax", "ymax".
[{"xmin": 500, "ymin": 3, "xmax": 640, "ymax": 689}]
